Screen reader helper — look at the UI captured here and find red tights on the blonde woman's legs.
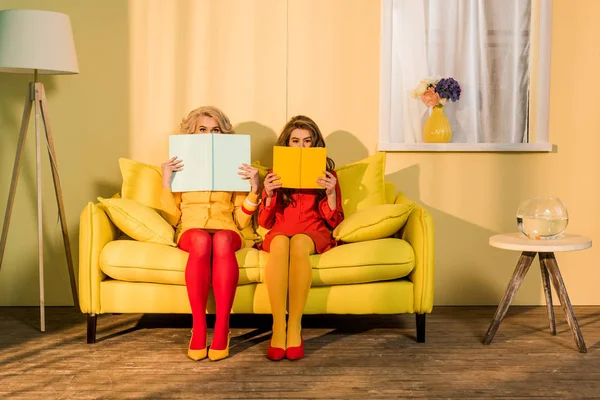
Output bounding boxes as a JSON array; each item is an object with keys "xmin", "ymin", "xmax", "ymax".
[{"xmin": 179, "ymin": 229, "xmax": 242, "ymax": 350}]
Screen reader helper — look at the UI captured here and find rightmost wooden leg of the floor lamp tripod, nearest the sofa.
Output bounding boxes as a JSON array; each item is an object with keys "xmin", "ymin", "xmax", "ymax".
[{"xmin": 36, "ymin": 82, "xmax": 81, "ymax": 312}]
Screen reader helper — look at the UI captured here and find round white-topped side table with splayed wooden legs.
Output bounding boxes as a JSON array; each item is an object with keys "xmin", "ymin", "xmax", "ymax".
[{"xmin": 483, "ymin": 233, "xmax": 592, "ymax": 353}]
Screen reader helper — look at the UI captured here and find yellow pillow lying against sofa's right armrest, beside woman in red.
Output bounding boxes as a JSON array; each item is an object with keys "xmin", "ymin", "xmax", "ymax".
[{"xmin": 333, "ymin": 203, "xmax": 415, "ymax": 243}]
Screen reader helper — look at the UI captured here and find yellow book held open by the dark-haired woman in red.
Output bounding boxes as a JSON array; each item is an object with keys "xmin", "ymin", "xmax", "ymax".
[{"xmin": 273, "ymin": 146, "xmax": 327, "ymax": 189}]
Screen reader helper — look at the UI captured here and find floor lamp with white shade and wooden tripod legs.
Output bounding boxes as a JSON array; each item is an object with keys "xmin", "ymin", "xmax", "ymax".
[{"xmin": 0, "ymin": 10, "xmax": 79, "ymax": 332}]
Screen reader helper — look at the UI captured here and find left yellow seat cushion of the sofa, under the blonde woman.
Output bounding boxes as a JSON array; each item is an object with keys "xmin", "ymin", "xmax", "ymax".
[{"xmin": 100, "ymin": 240, "xmax": 260, "ymax": 285}]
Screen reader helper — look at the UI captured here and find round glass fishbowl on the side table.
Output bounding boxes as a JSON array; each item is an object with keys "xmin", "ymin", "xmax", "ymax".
[{"xmin": 517, "ymin": 197, "xmax": 569, "ymax": 239}]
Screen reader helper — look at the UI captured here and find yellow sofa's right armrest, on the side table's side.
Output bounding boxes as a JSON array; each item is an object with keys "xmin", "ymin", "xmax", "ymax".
[{"xmin": 395, "ymin": 194, "xmax": 435, "ymax": 313}]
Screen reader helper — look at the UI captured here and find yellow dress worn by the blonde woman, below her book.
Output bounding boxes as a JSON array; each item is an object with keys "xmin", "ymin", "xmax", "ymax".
[{"xmin": 160, "ymin": 188, "xmax": 258, "ymax": 243}]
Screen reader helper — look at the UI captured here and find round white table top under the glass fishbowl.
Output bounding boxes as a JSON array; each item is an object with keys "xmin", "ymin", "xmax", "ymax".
[{"xmin": 489, "ymin": 232, "xmax": 592, "ymax": 253}]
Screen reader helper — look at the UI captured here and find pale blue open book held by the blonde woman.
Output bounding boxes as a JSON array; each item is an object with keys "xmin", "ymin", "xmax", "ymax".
[{"xmin": 169, "ymin": 133, "xmax": 250, "ymax": 192}]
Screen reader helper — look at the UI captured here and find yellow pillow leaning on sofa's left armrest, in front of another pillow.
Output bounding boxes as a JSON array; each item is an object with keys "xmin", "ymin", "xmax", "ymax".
[{"xmin": 98, "ymin": 197, "xmax": 176, "ymax": 246}]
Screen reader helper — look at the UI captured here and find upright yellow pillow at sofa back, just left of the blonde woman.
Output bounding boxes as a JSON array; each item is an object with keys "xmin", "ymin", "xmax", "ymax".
[{"xmin": 119, "ymin": 158, "xmax": 162, "ymax": 210}]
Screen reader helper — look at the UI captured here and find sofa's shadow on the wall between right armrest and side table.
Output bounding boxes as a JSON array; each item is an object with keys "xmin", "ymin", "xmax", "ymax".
[{"xmin": 385, "ymin": 165, "xmax": 541, "ymax": 306}]
